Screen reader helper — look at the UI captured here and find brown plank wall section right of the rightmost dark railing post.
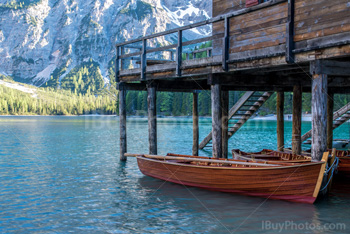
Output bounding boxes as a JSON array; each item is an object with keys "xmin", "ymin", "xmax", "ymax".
[{"xmin": 294, "ymin": 0, "xmax": 350, "ymax": 42}]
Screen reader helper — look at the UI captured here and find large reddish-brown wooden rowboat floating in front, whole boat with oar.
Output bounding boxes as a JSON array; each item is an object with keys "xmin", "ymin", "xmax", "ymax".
[{"xmin": 133, "ymin": 152, "xmax": 329, "ymax": 203}]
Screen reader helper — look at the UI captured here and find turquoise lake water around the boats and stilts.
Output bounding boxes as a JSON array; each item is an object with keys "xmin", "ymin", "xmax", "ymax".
[{"xmin": 0, "ymin": 116, "xmax": 350, "ymax": 233}]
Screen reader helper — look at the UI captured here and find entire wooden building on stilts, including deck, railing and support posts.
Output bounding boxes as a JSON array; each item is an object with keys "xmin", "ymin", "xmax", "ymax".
[{"xmin": 116, "ymin": 0, "xmax": 350, "ymax": 160}]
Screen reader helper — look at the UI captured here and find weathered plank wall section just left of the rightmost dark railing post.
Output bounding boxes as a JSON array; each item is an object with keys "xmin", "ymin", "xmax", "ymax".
[{"xmin": 213, "ymin": 0, "xmax": 288, "ymax": 59}]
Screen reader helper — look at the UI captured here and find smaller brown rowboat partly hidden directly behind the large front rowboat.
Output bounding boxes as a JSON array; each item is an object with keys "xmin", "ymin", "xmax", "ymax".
[{"xmin": 232, "ymin": 149, "xmax": 311, "ymax": 163}]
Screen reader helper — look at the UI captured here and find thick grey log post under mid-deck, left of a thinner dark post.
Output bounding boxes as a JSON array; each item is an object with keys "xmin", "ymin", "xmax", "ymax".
[{"xmin": 211, "ymin": 84, "xmax": 222, "ymax": 158}]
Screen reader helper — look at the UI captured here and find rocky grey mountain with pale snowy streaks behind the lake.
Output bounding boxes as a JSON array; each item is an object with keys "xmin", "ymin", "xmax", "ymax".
[{"xmin": 0, "ymin": 0, "xmax": 211, "ymax": 89}]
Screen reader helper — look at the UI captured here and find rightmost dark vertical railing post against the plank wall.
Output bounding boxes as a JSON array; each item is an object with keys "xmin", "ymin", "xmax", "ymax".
[{"xmin": 286, "ymin": 0, "xmax": 295, "ymax": 63}]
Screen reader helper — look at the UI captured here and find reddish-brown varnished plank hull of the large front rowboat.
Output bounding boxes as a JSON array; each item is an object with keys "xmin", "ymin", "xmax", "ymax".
[{"xmin": 137, "ymin": 157, "xmax": 323, "ymax": 204}]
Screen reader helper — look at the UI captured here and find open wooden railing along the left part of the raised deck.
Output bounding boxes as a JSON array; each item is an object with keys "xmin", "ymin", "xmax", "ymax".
[{"xmin": 116, "ymin": 0, "xmax": 286, "ymax": 82}]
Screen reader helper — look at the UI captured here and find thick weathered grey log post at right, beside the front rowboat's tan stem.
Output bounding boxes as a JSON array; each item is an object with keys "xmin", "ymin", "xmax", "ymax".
[{"xmin": 311, "ymin": 74, "xmax": 327, "ymax": 161}]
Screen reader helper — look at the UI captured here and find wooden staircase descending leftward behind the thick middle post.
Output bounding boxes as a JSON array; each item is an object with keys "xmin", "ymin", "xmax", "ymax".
[{"xmin": 199, "ymin": 91, "xmax": 273, "ymax": 149}]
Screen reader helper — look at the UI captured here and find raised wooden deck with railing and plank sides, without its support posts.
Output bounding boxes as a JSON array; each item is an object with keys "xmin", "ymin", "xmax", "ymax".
[{"xmin": 117, "ymin": 0, "xmax": 350, "ymax": 92}]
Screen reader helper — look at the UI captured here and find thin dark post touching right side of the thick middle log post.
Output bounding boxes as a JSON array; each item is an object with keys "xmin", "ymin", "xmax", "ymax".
[{"xmin": 221, "ymin": 91, "xmax": 229, "ymax": 158}]
